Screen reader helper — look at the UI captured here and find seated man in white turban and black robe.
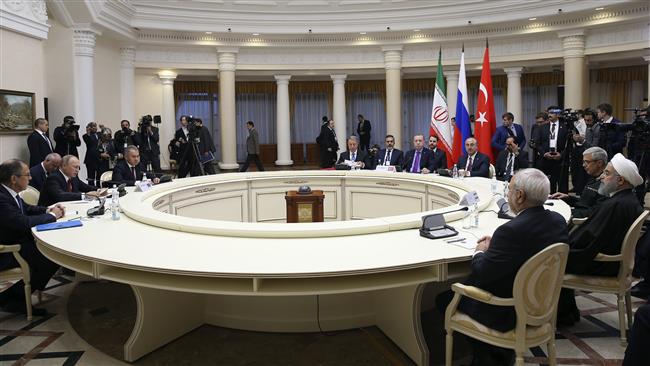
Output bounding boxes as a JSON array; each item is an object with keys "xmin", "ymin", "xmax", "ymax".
[{"xmin": 558, "ymin": 153, "xmax": 643, "ymax": 325}]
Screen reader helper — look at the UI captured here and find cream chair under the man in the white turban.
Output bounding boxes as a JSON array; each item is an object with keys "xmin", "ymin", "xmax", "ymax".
[{"xmin": 563, "ymin": 211, "xmax": 650, "ymax": 346}]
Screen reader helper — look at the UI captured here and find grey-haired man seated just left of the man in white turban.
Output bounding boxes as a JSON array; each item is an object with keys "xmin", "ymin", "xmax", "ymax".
[{"xmin": 550, "ymin": 146, "xmax": 607, "ymax": 218}]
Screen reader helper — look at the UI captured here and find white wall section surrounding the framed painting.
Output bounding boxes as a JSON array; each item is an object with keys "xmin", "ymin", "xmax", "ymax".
[{"xmin": 0, "ymin": 29, "xmax": 46, "ymax": 161}]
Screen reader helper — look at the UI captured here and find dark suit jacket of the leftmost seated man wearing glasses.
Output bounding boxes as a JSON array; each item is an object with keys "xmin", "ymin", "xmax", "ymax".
[{"xmin": 0, "ymin": 185, "xmax": 56, "ymax": 270}]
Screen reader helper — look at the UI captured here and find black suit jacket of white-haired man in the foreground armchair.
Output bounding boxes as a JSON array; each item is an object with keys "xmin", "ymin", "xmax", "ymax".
[{"xmin": 460, "ymin": 206, "xmax": 568, "ymax": 332}]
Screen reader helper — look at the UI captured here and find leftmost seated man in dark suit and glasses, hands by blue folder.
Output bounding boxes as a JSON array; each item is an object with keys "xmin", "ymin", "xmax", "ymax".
[{"xmin": 0, "ymin": 159, "xmax": 64, "ymax": 316}]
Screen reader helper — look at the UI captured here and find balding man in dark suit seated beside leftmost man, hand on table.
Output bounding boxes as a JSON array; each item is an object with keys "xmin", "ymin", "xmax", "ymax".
[{"xmin": 38, "ymin": 155, "xmax": 106, "ymax": 206}]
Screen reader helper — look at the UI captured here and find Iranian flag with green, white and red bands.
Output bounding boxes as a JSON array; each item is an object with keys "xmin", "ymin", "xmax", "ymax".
[{"xmin": 429, "ymin": 48, "xmax": 456, "ymax": 165}]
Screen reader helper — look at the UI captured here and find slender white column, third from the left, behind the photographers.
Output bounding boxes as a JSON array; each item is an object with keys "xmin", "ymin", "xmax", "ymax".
[{"xmin": 158, "ymin": 71, "xmax": 177, "ymax": 169}]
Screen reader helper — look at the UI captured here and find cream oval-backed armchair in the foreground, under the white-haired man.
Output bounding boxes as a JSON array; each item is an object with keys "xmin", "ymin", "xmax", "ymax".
[{"xmin": 445, "ymin": 243, "xmax": 569, "ymax": 366}]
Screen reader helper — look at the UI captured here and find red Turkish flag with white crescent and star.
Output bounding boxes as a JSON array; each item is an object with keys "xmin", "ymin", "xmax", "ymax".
[{"xmin": 474, "ymin": 45, "xmax": 497, "ymax": 164}]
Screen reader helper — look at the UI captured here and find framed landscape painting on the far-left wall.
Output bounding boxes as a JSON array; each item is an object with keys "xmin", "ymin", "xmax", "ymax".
[{"xmin": 0, "ymin": 89, "xmax": 36, "ymax": 134}]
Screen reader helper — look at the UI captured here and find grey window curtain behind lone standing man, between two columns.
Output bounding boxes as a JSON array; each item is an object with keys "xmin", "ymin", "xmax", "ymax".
[{"xmin": 344, "ymin": 91, "xmax": 386, "ymax": 150}]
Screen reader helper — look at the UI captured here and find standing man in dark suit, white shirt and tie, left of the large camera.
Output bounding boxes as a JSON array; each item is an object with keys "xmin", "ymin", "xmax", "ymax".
[{"xmin": 535, "ymin": 106, "xmax": 569, "ymax": 193}]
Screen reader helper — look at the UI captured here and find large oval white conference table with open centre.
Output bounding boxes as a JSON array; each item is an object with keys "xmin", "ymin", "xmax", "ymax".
[{"xmin": 33, "ymin": 171, "xmax": 570, "ymax": 365}]
